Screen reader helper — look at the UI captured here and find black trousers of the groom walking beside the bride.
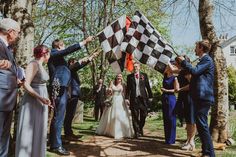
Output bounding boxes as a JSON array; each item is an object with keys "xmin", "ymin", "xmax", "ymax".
[{"xmin": 130, "ymin": 97, "xmax": 147, "ymax": 135}]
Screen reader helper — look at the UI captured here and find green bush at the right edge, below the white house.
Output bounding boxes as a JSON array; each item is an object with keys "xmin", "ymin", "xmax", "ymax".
[{"xmin": 227, "ymin": 66, "xmax": 236, "ymax": 105}]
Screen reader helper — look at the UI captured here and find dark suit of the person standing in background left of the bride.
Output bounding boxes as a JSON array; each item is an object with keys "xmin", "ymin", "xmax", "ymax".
[{"xmin": 93, "ymin": 85, "xmax": 106, "ymax": 120}]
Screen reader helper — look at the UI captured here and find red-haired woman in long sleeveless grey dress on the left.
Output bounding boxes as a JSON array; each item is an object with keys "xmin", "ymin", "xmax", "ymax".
[{"xmin": 15, "ymin": 45, "xmax": 51, "ymax": 157}]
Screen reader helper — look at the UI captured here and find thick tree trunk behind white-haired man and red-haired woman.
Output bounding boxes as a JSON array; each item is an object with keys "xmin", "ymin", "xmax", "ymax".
[{"xmin": 1, "ymin": 0, "xmax": 34, "ymax": 142}]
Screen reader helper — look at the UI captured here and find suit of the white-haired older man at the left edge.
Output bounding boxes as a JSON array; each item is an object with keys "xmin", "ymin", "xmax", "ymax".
[{"xmin": 0, "ymin": 39, "xmax": 17, "ymax": 157}]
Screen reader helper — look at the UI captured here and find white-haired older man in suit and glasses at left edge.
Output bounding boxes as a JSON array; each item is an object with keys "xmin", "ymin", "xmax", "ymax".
[{"xmin": 0, "ymin": 18, "xmax": 20, "ymax": 157}]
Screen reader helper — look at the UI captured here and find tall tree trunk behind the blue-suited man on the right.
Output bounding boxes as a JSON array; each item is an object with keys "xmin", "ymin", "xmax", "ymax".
[{"xmin": 199, "ymin": 0, "xmax": 229, "ymax": 142}]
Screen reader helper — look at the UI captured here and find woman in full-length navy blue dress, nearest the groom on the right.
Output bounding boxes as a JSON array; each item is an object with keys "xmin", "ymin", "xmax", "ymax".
[{"xmin": 161, "ymin": 63, "xmax": 179, "ymax": 144}]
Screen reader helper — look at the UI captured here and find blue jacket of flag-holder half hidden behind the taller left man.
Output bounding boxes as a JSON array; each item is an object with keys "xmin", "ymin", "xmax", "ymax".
[{"xmin": 70, "ymin": 61, "xmax": 90, "ymax": 97}]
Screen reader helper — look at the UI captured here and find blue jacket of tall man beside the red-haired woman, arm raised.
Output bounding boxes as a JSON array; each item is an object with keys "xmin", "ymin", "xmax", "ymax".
[{"xmin": 48, "ymin": 44, "xmax": 81, "ymax": 87}]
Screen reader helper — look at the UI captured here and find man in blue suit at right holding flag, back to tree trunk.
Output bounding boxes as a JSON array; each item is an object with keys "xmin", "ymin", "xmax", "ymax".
[{"xmin": 177, "ymin": 40, "xmax": 215, "ymax": 157}]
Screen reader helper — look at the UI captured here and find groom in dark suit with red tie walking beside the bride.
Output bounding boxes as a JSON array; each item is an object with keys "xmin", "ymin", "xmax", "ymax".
[{"xmin": 125, "ymin": 62, "xmax": 153, "ymax": 138}]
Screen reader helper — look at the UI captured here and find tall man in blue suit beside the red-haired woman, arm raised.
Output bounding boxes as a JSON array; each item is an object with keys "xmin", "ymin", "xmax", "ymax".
[{"xmin": 48, "ymin": 36, "xmax": 93, "ymax": 155}]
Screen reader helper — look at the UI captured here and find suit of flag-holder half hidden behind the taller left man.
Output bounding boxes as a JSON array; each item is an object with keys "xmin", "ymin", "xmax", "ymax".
[{"xmin": 64, "ymin": 61, "xmax": 90, "ymax": 135}]
